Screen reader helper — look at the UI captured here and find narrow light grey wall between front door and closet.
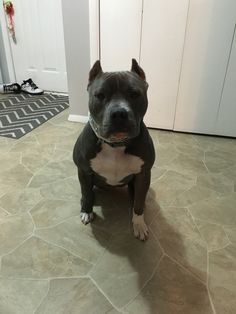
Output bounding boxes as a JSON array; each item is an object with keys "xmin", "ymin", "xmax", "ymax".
[{"xmin": 62, "ymin": 0, "xmax": 90, "ymax": 116}]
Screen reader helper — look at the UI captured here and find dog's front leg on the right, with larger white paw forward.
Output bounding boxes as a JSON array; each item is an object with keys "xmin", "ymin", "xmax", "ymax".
[{"xmin": 132, "ymin": 170, "xmax": 151, "ymax": 241}]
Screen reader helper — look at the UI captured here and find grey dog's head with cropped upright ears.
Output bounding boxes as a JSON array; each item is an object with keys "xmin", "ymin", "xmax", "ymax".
[{"xmin": 88, "ymin": 59, "xmax": 148, "ymax": 142}]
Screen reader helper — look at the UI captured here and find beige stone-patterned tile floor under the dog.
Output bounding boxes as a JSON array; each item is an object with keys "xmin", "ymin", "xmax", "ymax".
[{"xmin": 0, "ymin": 107, "xmax": 236, "ymax": 314}]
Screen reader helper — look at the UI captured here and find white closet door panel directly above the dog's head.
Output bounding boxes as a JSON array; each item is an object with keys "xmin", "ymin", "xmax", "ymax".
[{"xmin": 100, "ymin": 0, "xmax": 142, "ymax": 71}]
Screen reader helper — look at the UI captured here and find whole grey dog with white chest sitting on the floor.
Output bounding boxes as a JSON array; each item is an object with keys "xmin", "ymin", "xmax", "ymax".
[{"xmin": 73, "ymin": 59, "xmax": 155, "ymax": 240}]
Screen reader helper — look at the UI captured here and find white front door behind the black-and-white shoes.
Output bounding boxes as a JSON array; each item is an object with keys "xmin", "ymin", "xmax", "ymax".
[{"xmin": 6, "ymin": 0, "xmax": 67, "ymax": 92}]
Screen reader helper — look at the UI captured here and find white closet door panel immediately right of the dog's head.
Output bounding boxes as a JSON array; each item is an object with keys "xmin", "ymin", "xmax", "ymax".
[{"xmin": 140, "ymin": 0, "xmax": 189, "ymax": 129}]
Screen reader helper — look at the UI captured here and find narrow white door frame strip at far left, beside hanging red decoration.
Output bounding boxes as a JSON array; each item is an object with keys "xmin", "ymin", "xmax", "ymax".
[{"xmin": 0, "ymin": 1, "xmax": 16, "ymax": 82}]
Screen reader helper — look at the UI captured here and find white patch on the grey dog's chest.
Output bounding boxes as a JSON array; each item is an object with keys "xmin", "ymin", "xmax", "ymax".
[{"xmin": 90, "ymin": 143, "xmax": 144, "ymax": 185}]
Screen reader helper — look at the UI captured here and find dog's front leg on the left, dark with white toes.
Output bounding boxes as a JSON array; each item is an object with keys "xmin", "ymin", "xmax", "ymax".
[{"xmin": 78, "ymin": 170, "xmax": 94, "ymax": 225}]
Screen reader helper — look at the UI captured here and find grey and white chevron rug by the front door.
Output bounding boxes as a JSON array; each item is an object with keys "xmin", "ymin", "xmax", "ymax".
[{"xmin": 0, "ymin": 94, "xmax": 69, "ymax": 139}]
